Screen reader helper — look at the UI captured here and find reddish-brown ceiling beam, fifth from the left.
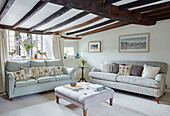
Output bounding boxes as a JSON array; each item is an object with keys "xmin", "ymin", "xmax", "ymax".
[{"xmin": 56, "ymin": 17, "xmax": 103, "ymax": 33}]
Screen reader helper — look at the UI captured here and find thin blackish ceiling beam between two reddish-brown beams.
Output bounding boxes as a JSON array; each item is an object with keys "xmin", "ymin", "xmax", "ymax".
[{"xmin": 67, "ymin": 20, "xmax": 114, "ymax": 35}]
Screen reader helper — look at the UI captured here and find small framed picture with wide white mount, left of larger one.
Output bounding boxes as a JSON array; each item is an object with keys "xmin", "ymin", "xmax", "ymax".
[{"xmin": 88, "ymin": 41, "xmax": 101, "ymax": 53}]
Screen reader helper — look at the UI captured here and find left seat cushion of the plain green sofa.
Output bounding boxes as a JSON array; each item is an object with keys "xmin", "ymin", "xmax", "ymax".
[{"xmin": 15, "ymin": 78, "xmax": 38, "ymax": 87}]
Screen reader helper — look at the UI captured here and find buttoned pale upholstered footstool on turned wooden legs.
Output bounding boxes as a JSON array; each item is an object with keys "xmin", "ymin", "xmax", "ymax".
[{"xmin": 55, "ymin": 82, "xmax": 114, "ymax": 116}]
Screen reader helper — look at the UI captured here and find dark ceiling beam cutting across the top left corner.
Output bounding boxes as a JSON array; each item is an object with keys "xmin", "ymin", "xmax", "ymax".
[{"xmin": 0, "ymin": 0, "xmax": 15, "ymax": 21}]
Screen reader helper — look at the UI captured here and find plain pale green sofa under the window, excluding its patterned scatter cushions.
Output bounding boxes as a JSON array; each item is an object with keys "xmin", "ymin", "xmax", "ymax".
[{"xmin": 5, "ymin": 60, "xmax": 75, "ymax": 100}]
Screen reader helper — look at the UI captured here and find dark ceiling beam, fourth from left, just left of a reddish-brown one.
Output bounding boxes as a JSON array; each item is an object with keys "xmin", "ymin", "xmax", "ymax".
[{"xmin": 43, "ymin": 12, "xmax": 89, "ymax": 33}]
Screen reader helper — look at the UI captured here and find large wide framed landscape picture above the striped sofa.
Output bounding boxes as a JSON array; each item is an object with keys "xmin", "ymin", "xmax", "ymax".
[{"xmin": 119, "ymin": 33, "xmax": 150, "ymax": 53}]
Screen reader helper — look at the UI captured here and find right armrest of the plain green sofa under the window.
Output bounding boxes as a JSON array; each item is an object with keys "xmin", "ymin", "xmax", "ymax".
[{"xmin": 63, "ymin": 67, "xmax": 76, "ymax": 81}]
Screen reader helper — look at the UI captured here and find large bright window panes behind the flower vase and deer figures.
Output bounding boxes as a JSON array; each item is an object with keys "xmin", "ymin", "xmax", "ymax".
[{"xmin": 8, "ymin": 31, "xmax": 43, "ymax": 56}]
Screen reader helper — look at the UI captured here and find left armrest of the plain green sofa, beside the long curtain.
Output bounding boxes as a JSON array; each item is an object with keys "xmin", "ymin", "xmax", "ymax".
[{"xmin": 5, "ymin": 72, "xmax": 15, "ymax": 98}]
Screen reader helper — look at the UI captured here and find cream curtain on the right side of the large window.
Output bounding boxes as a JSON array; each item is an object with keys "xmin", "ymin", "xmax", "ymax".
[{"xmin": 52, "ymin": 35, "xmax": 64, "ymax": 65}]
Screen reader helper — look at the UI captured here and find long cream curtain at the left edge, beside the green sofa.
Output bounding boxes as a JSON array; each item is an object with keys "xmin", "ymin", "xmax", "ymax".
[{"xmin": 0, "ymin": 29, "xmax": 8, "ymax": 93}]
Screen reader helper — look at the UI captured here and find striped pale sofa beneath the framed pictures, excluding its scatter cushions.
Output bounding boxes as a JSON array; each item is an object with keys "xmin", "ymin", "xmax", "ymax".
[{"xmin": 89, "ymin": 61, "xmax": 168, "ymax": 103}]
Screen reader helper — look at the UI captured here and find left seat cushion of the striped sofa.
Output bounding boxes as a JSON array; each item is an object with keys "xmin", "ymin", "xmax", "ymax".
[{"xmin": 89, "ymin": 72, "xmax": 118, "ymax": 81}]
